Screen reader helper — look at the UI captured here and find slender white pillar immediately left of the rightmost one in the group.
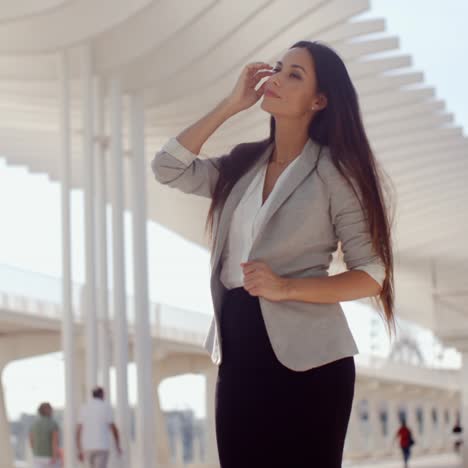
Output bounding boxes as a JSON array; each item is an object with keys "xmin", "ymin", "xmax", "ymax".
[{"xmin": 110, "ymin": 78, "xmax": 131, "ymax": 468}]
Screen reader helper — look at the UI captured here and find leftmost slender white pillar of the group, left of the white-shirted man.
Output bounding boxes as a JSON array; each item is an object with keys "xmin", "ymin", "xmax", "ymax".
[{"xmin": 58, "ymin": 51, "xmax": 76, "ymax": 468}]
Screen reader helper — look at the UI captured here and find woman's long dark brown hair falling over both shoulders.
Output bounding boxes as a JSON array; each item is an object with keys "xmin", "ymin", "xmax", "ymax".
[{"xmin": 206, "ymin": 41, "xmax": 395, "ymax": 337}]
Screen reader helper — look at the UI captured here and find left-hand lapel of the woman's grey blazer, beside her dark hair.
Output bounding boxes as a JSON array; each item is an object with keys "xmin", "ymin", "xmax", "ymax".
[{"xmin": 211, "ymin": 143, "xmax": 273, "ymax": 272}]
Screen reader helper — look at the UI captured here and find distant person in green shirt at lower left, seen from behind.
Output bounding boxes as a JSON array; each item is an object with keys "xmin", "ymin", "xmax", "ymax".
[{"xmin": 29, "ymin": 402, "xmax": 59, "ymax": 468}]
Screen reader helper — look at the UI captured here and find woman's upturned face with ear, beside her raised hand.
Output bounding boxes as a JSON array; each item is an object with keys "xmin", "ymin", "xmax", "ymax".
[{"xmin": 261, "ymin": 47, "xmax": 326, "ymax": 117}]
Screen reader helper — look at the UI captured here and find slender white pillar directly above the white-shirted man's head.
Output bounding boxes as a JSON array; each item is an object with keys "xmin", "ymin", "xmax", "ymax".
[{"xmin": 81, "ymin": 44, "xmax": 98, "ymax": 392}]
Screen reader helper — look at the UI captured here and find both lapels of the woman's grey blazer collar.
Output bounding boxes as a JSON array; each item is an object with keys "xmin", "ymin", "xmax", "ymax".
[{"xmin": 211, "ymin": 138, "xmax": 320, "ymax": 272}]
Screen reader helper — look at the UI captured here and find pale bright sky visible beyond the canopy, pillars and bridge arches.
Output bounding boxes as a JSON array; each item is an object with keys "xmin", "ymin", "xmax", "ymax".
[{"xmin": 0, "ymin": 0, "xmax": 468, "ymax": 419}]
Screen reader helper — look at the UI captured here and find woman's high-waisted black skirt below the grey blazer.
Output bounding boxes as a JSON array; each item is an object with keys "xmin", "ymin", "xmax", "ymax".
[{"xmin": 215, "ymin": 287, "xmax": 355, "ymax": 468}]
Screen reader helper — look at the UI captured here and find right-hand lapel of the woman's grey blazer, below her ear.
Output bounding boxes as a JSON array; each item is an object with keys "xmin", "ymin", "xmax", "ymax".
[{"xmin": 249, "ymin": 138, "xmax": 320, "ymax": 260}]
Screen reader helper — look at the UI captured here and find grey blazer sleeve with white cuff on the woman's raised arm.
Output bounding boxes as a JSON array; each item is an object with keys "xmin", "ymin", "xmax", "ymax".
[{"xmin": 151, "ymin": 137, "xmax": 227, "ymax": 198}]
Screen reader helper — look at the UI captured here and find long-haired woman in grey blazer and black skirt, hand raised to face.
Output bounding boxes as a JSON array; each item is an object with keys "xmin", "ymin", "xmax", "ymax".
[{"xmin": 152, "ymin": 41, "xmax": 394, "ymax": 468}]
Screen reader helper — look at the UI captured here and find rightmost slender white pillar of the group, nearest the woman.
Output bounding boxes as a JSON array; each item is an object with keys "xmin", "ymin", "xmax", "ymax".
[{"xmin": 130, "ymin": 95, "xmax": 155, "ymax": 468}]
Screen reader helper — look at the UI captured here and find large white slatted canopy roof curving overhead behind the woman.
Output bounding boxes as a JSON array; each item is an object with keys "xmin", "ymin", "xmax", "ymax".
[{"xmin": 0, "ymin": 0, "xmax": 468, "ymax": 336}]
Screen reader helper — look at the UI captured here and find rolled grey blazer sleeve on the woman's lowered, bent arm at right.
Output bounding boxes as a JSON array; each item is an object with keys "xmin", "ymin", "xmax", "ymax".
[{"xmin": 328, "ymin": 164, "xmax": 385, "ymax": 287}]
